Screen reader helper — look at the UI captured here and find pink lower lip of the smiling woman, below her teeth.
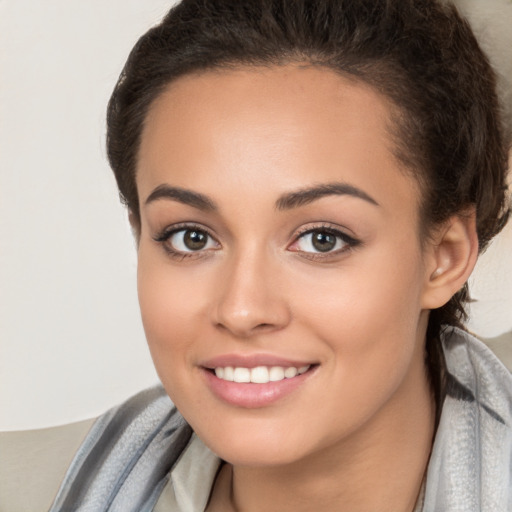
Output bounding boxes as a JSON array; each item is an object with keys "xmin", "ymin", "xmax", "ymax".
[{"xmin": 203, "ymin": 367, "xmax": 315, "ymax": 409}]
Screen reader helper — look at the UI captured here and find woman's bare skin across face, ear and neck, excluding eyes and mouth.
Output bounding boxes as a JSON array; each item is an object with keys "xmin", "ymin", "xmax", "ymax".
[{"xmin": 136, "ymin": 65, "xmax": 476, "ymax": 512}]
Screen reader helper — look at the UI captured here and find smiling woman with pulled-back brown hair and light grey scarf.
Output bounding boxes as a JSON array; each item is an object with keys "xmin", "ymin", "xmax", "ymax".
[{"xmin": 52, "ymin": 0, "xmax": 512, "ymax": 511}]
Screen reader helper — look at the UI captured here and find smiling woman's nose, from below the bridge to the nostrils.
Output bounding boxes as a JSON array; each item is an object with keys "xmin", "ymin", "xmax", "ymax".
[{"xmin": 213, "ymin": 250, "xmax": 291, "ymax": 338}]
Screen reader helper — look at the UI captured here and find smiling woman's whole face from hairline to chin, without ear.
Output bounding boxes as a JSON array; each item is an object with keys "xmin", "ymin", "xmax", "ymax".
[{"xmin": 137, "ymin": 65, "xmax": 431, "ymax": 465}]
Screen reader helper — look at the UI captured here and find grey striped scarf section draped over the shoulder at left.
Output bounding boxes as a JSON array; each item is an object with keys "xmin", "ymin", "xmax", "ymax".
[{"xmin": 50, "ymin": 386, "xmax": 192, "ymax": 512}]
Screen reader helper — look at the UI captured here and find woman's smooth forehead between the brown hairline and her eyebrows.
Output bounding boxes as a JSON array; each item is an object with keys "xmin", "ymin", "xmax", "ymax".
[{"xmin": 137, "ymin": 65, "xmax": 418, "ymax": 216}]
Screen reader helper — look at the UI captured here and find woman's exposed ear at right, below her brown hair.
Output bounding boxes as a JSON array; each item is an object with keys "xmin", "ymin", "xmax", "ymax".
[{"xmin": 422, "ymin": 208, "xmax": 478, "ymax": 309}]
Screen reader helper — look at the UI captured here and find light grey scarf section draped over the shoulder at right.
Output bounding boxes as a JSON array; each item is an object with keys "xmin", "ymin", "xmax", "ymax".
[{"xmin": 424, "ymin": 329, "xmax": 512, "ymax": 512}]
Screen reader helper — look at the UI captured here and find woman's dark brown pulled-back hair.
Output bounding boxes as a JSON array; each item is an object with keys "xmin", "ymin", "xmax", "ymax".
[{"xmin": 107, "ymin": 0, "xmax": 508, "ymax": 396}]
